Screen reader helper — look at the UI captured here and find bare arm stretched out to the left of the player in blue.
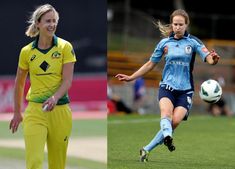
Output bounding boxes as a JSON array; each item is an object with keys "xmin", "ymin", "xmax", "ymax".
[{"xmin": 115, "ymin": 60, "xmax": 156, "ymax": 82}]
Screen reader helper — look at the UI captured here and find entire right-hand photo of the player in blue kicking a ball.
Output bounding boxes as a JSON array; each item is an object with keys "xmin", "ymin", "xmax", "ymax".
[{"xmin": 107, "ymin": 0, "xmax": 235, "ymax": 169}]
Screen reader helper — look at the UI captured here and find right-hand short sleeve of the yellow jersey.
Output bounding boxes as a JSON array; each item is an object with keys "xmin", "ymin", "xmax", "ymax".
[{"xmin": 63, "ymin": 42, "xmax": 76, "ymax": 64}]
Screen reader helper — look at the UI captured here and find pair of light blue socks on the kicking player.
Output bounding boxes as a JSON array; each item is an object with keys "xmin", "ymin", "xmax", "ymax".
[{"xmin": 144, "ymin": 117, "xmax": 173, "ymax": 151}]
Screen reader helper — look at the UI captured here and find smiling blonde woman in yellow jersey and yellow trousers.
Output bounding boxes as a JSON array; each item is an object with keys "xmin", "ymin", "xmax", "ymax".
[{"xmin": 10, "ymin": 4, "xmax": 76, "ymax": 169}]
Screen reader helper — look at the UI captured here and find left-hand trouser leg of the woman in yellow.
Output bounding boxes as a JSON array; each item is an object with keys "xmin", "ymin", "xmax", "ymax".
[{"xmin": 23, "ymin": 103, "xmax": 47, "ymax": 168}]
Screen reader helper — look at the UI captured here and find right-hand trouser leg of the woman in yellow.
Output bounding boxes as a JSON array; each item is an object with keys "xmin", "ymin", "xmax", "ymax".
[{"xmin": 47, "ymin": 105, "xmax": 72, "ymax": 169}]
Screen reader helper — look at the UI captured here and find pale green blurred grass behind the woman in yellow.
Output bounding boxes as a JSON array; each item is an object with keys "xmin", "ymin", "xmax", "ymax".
[{"xmin": 0, "ymin": 119, "xmax": 107, "ymax": 169}]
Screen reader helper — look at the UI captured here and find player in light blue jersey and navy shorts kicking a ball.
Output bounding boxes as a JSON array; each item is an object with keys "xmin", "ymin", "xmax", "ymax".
[{"xmin": 116, "ymin": 9, "xmax": 220, "ymax": 162}]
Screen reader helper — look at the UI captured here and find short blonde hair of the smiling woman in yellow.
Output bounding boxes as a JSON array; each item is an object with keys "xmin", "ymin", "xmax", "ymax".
[{"xmin": 25, "ymin": 4, "xmax": 59, "ymax": 38}]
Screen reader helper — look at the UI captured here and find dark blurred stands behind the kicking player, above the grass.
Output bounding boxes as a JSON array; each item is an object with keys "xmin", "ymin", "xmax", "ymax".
[{"xmin": 107, "ymin": 0, "xmax": 235, "ymax": 115}]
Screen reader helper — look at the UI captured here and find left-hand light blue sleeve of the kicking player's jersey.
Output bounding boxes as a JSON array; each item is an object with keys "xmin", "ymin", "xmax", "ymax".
[{"xmin": 150, "ymin": 39, "xmax": 165, "ymax": 63}]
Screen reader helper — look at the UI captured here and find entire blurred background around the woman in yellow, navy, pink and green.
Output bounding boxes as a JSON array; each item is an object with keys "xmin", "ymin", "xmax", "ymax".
[{"xmin": 0, "ymin": 0, "xmax": 107, "ymax": 169}]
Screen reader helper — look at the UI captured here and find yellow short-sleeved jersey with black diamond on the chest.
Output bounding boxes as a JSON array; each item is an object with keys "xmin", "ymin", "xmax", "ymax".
[{"xmin": 18, "ymin": 36, "xmax": 76, "ymax": 105}]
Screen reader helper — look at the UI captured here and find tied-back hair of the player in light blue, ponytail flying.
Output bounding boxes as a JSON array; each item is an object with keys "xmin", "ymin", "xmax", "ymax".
[{"xmin": 155, "ymin": 9, "xmax": 190, "ymax": 37}]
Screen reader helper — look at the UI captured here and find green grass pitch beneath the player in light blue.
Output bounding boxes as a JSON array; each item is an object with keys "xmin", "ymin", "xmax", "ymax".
[{"xmin": 108, "ymin": 115, "xmax": 235, "ymax": 169}]
